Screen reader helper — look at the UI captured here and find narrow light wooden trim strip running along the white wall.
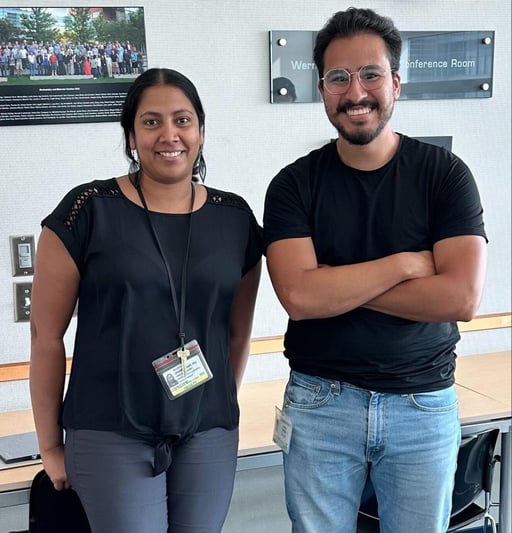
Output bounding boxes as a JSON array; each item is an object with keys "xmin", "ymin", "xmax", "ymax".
[{"xmin": 0, "ymin": 313, "xmax": 512, "ymax": 383}]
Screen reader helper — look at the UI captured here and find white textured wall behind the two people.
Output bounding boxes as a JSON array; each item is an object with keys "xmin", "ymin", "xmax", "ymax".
[{"xmin": 0, "ymin": 0, "xmax": 511, "ymax": 410}]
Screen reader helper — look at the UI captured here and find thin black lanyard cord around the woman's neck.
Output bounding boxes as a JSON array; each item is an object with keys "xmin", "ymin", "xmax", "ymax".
[{"xmin": 135, "ymin": 176, "xmax": 196, "ymax": 349}]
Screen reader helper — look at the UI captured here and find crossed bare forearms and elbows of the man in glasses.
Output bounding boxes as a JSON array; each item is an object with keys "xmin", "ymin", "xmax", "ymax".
[{"xmin": 267, "ymin": 235, "xmax": 487, "ymax": 322}]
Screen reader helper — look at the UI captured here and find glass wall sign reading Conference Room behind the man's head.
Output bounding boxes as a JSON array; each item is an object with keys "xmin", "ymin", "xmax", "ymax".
[{"xmin": 269, "ymin": 30, "xmax": 494, "ymax": 103}]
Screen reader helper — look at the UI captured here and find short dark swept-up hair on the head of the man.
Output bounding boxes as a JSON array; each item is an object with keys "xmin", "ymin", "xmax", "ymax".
[{"xmin": 313, "ymin": 7, "xmax": 402, "ymax": 78}]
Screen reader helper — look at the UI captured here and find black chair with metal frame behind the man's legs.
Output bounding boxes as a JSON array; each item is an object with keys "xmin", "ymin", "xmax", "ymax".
[{"xmin": 357, "ymin": 429, "xmax": 500, "ymax": 533}]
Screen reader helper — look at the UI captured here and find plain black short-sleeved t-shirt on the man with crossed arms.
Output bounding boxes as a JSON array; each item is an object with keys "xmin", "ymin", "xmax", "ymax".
[{"xmin": 264, "ymin": 135, "xmax": 486, "ymax": 393}]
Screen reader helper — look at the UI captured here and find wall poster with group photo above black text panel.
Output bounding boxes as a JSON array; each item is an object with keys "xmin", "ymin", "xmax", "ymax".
[{"xmin": 0, "ymin": 7, "xmax": 147, "ymax": 126}]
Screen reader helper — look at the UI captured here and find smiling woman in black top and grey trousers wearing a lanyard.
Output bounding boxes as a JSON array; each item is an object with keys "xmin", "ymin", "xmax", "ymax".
[{"xmin": 30, "ymin": 69, "xmax": 261, "ymax": 533}]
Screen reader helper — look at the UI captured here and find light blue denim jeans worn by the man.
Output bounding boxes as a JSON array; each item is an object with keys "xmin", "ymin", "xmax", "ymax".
[{"xmin": 283, "ymin": 371, "xmax": 460, "ymax": 533}]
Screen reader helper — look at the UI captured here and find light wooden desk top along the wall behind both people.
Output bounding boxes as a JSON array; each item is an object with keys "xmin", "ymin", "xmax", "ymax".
[{"xmin": 0, "ymin": 351, "xmax": 512, "ymax": 491}]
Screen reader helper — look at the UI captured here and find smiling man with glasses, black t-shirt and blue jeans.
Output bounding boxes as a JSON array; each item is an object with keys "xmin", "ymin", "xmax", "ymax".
[{"xmin": 264, "ymin": 8, "xmax": 486, "ymax": 533}]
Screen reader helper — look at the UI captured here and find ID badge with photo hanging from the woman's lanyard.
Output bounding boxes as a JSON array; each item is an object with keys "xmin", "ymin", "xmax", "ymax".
[{"xmin": 152, "ymin": 339, "xmax": 213, "ymax": 400}]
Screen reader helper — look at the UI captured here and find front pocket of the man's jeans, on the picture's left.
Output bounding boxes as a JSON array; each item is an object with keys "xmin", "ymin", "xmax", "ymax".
[{"xmin": 284, "ymin": 371, "xmax": 332, "ymax": 409}]
